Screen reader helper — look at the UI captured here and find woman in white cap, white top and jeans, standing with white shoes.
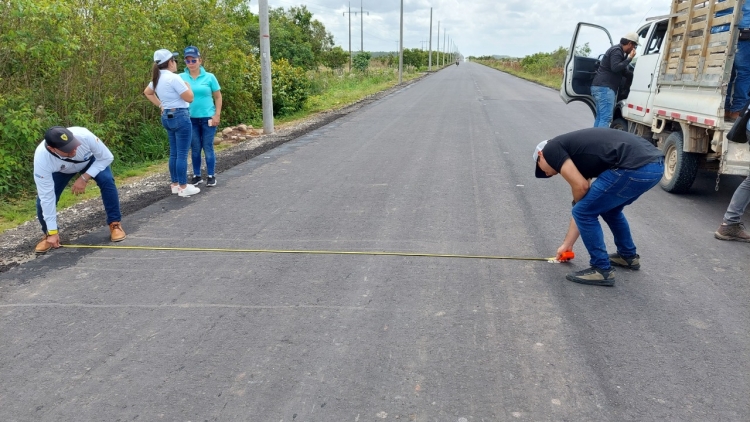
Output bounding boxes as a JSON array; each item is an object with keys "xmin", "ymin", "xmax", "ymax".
[{"xmin": 143, "ymin": 49, "xmax": 201, "ymax": 197}]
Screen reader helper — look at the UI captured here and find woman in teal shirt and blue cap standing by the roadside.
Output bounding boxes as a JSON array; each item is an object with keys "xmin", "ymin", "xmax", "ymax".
[{"xmin": 180, "ymin": 46, "xmax": 221, "ymax": 186}]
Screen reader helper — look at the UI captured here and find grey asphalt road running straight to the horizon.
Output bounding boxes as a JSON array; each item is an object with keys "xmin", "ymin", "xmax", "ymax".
[{"xmin": 0, "ymin": 63, "xmax": 750, "ymax": 422}]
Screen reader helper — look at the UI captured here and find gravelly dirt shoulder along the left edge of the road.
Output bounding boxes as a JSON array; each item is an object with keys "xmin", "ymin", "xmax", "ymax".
[{"xmin": 0, "ymin": 74, "xmax": 427, "ymax": 273}]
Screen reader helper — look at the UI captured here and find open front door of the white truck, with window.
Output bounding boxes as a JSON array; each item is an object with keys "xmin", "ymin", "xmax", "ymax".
[{"xmin": 560, "ymin": 22, "xmax": 613, "ymax": 115}]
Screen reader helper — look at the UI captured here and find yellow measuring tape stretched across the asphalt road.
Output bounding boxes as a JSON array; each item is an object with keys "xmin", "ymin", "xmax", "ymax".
[{"xmin": 60, "ymin": 245, "xmax": 557, "ymax": 262}]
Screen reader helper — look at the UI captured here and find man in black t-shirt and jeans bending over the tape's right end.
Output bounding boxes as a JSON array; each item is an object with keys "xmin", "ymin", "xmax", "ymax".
[{"xmin": 534, "ymin": 128, "xmax": 664, "ymax": 286}]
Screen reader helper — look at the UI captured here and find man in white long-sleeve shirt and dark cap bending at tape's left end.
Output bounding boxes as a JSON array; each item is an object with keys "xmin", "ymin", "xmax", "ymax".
[{"xmin": 34, "ymin": 126, "xmax": 126, "ymax": 254}]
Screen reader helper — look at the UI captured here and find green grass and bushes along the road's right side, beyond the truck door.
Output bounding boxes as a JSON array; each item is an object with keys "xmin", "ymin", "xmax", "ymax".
[{"xmin": 476, "ymin": 43, "xmax": 591, "ymax": 89}]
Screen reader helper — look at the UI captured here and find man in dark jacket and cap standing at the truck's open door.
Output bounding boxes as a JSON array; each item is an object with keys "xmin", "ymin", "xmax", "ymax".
[{"xmin": 591, "ymin": 32, "xmax": 638, "ymax": 127}]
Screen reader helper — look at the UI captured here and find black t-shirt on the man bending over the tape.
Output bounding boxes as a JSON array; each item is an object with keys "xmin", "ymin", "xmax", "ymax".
[{"xmin": 543, "ymin": 127, "xmax": 664, "ymax": 179}]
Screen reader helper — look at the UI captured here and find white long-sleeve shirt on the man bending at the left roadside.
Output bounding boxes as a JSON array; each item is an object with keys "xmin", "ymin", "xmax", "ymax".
[{"xmin": 34, "ymin": 126, "xmax": 115, "ymax": 230}]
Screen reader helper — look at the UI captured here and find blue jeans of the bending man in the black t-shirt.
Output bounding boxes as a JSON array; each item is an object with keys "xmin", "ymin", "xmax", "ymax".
[{"xmin": 573, "ymin": 159, "xmax": 664, "ymax": 270}]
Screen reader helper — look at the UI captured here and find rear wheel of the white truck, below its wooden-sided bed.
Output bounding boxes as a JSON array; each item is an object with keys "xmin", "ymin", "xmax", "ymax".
[{"xmin": 659, "ymin": 132, "xmax": 698, "ymax": 193}]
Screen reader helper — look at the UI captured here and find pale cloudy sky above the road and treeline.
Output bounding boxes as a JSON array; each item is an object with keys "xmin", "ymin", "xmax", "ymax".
[{"xmin": 250, "ymin": 0, "xmax": 671, "ymax": 57}]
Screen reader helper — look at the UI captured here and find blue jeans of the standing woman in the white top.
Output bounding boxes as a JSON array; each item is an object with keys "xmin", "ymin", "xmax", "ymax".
[{"xmin": 161, "ymin": 108, "xmax": 193, "ymax": 185}]
